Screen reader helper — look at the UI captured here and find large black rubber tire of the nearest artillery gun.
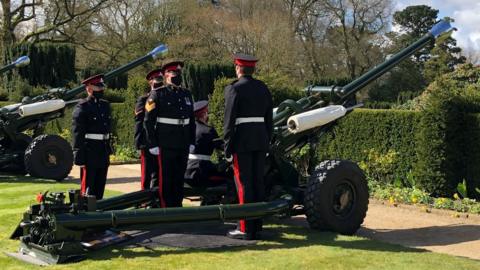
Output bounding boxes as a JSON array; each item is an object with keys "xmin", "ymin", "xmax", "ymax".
[{"xmin": 304, "ymin": 160, "xmax": 369, "ymax": 235}]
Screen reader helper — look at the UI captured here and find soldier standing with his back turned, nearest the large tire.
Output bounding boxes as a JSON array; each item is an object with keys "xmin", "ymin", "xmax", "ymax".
[{"xmin": 224, "ymin": 54, "xmax": 273, "ymax": 239}]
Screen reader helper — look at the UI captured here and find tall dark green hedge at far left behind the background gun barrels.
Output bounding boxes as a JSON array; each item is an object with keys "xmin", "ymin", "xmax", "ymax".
[{"xmin": 5, "ymin": 43, "xmax": 77, "ymax": 87}]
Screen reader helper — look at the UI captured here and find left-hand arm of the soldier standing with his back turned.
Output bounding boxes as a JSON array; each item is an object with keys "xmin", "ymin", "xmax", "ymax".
[{"xmin": 223, "ymin": 85, "xmax": 238, "ymax": 157}]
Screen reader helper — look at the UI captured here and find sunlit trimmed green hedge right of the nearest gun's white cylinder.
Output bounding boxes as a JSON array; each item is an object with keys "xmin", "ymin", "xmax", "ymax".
[{"xmin": 318, "ymin": 109, "xmax": 421, "ymax": 183}]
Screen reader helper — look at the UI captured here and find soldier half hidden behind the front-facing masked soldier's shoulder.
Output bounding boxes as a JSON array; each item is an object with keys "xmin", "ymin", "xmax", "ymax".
[{"xmin": 135, "ymin": 69, "xmax": 163, "ymax": 190}]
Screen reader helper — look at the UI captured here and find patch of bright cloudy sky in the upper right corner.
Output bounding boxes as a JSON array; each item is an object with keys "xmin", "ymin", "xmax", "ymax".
[{"xmin": 395, "ymin": 0, "xmax": 480, "ymax": 53}]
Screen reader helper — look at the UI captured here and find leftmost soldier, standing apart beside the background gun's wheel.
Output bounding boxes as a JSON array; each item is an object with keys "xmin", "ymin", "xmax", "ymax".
[{"xmin": 72, "ymin": 74, "xmax": 112, "ymax": 200}]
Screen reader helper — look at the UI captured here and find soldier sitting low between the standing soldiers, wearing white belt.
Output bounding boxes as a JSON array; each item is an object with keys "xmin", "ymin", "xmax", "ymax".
[{"xmin": 185, "ymin": 100, "xmax": 226, "ymax": 186}]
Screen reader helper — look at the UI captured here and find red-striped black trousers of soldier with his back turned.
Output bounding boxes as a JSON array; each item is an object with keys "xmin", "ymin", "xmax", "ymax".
[{"xmin": 233, "ymin": 151, "xmax": 266, "ymax": 233}]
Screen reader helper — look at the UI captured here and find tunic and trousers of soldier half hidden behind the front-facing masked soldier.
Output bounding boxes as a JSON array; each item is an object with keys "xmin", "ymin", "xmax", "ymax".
[{"xmin": 134, "ymin": 92, "xmax": 158, "ymax": 190}]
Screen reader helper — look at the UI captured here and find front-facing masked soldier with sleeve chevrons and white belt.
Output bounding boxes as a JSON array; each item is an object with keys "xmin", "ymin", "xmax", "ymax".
[{"xmin": 144, "ymin": 61, "xmax": 195, "ymax": 207}]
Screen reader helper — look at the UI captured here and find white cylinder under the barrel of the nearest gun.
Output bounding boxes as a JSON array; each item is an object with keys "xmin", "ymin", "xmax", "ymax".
[{"xmin": 287, "ymin": 105, "xmax": 347, "ymax": 133}]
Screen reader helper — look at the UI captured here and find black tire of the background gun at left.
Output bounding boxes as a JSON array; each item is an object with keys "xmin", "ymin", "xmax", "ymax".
[{"xmin": 25, "ymin": 134, "xmax": 73, "ymax": 181}]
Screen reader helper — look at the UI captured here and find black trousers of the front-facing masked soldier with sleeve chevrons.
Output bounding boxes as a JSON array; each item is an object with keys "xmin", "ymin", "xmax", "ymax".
[{"xmin": 157, "ymin": 148, "xmax": 188, "ymax": 207}]
